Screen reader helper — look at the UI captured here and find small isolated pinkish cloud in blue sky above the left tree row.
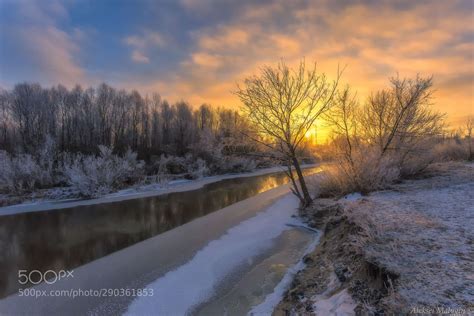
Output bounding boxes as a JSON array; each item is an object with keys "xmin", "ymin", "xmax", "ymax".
[{"xmin": 123, "ymin": 30, "xmax": 166, "ymax": 64}]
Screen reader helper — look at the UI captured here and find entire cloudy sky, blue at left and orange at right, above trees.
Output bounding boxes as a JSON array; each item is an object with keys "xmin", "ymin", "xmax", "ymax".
[{"xmin": 0, "ymin": 0, "xmax": 474, "ymax": 125}]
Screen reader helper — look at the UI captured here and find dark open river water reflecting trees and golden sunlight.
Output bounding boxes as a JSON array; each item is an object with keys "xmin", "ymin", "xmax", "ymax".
[{"xmin": 0, "ymin": 169, "xmax": 315, "ymax": 297}]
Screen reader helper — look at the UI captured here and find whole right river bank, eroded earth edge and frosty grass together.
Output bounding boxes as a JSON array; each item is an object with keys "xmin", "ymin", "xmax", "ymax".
[{"xmin": 274, "ymin": 163, "xmax": 474, "ymax": 315}]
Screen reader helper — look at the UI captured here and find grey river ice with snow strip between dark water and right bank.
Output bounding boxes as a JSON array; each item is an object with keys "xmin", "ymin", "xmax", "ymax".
[{"xmin": 0, "ymin": 184, "xmax": 317, "ymax": 315}]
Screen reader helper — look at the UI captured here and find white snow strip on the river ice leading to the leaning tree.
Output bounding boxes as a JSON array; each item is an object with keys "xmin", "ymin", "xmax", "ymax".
[{"xmin": 127, "ymin": 194, "xmax": 298, "ymax": 315}]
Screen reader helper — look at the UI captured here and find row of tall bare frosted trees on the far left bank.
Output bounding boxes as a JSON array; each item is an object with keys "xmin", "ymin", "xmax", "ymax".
[{"xmin": 0, "ymin": 83, "xmax": 252, "ymax": 161}]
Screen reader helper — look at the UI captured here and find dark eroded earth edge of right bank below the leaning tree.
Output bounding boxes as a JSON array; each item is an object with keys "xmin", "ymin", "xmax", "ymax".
[{"xmin": 273, "ymin": 199, "xmax": 366, "ymax": 316}]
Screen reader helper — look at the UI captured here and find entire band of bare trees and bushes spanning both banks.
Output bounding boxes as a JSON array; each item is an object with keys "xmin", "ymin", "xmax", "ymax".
[{"xmin": 0, "ymin": 60, "xmax": 474, "ymax": 206}]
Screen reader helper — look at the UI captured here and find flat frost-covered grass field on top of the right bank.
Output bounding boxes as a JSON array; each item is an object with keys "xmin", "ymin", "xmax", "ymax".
[{"xmin": 345, "ymin": 163, "xmax": 474, "ymax": 313}]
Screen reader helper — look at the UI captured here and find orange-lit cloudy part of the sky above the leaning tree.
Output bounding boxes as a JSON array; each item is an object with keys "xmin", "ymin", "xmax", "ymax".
[{"xmin": 135, "ymin": 1, "xmax": 474, "ymax": 130}]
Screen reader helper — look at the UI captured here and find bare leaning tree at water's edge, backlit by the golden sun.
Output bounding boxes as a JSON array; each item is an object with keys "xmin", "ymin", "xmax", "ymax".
[{"xmin": 235, "ymin": 60, "xmax": 341, "ymax": 206}]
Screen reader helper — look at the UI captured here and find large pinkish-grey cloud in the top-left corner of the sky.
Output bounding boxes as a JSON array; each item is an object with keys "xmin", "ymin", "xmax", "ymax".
[{"xmin": 2, "ymin": 0, "xmax": 91, "ymax": 86}]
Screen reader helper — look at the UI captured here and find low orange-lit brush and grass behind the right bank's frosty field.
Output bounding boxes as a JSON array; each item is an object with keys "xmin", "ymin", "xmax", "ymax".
[{"xmin": 312, "ymin": 138, "xmax": 474, "ymax": 198}]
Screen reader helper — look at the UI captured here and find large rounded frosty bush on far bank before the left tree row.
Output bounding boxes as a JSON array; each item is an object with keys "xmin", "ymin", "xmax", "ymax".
[{"xmin": 64, "ymin": 146, "xmax": 144, "ymax": 197}]
